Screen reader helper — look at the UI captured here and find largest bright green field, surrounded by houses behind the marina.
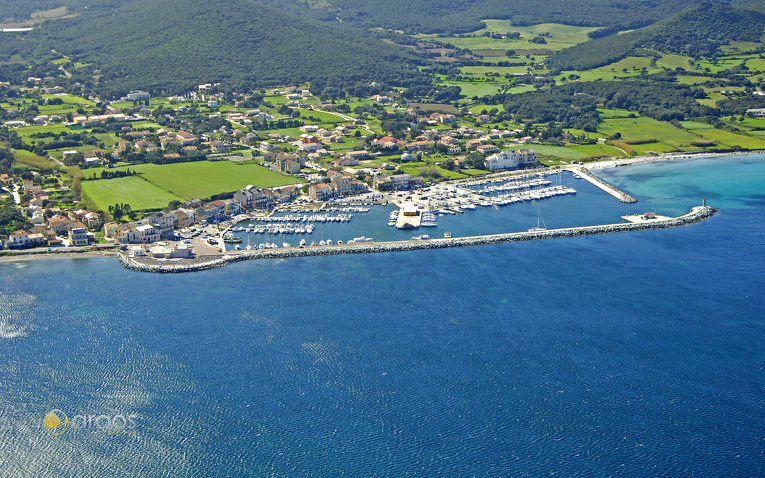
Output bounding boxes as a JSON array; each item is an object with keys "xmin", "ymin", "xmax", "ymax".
[{"xmin": 82, "ymin": 161, "xmax": 301, "ymax": 210}]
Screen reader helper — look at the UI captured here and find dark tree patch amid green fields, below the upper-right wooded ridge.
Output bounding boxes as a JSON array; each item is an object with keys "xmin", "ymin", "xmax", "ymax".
[{"xmin": 503, "ymin": 80, "xmax": 715, "ymax": 131}]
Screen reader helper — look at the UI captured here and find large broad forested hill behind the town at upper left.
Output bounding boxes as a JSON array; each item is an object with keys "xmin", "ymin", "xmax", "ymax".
[{"xmin": 6, "ymin": 0, "xmax": 424, "ymax": 94}]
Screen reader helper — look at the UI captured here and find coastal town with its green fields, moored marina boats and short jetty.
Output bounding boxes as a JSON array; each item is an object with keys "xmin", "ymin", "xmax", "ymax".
[{"xmin": 0, "ymin": 77, "xmax": 757, "ymax": 266}]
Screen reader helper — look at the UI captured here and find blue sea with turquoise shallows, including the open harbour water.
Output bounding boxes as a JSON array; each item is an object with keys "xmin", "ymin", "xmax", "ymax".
[{"xmin": 0, "ymin": 154, "xmax": 765, "ymax": 477}]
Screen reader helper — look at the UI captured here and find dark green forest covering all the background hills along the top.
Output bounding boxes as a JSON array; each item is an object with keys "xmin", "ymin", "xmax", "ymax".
[{"xmin": 0, "ymin": 0, "xmax": 765, "ymax": 101}]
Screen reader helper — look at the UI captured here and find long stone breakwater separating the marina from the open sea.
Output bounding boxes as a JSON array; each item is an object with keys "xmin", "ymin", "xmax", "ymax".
[{"xmin": 120, "ymin": 206, "xmax": 717, "ymax": 273}]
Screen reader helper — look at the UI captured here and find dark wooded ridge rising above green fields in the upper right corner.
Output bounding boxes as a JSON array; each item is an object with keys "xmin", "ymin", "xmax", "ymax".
[{"xmin": 547, "ymin": 3, "xmax": 765, "ymax": 70}]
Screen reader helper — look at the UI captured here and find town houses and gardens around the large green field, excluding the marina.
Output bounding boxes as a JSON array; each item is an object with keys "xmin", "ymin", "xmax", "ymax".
[{"xmin": 0, "ymin": 82, "xmax": 539, "ymax": 258}]
